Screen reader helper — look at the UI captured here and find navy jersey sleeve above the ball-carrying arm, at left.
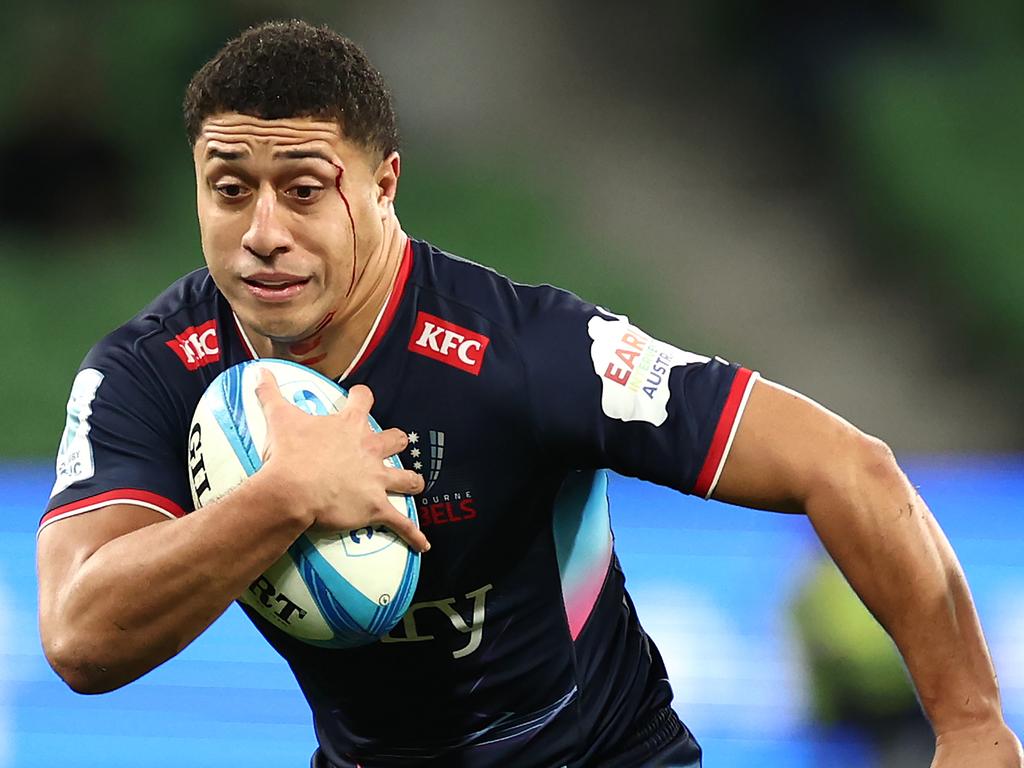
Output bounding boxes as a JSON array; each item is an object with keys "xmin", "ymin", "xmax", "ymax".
[{"xmin": 40, "ymin": 340, "xmax": 191, "ymax": 528}]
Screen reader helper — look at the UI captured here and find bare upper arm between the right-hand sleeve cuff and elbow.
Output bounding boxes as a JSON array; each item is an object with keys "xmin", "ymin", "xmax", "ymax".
[{"xmin": 712, "ymin": 379, "xmax": 870, "ymax": 512}]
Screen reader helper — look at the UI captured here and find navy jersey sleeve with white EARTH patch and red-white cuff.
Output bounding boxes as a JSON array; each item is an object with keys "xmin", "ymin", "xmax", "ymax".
[{"xmin": 520, "ymin": 287, "xmax": 757, "ymax": 498}]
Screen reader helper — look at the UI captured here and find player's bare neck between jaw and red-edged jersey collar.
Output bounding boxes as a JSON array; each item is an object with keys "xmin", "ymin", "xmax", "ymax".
[{"xmin": 246, "ymin": 215, "xmax": 409, "ymax": 379}]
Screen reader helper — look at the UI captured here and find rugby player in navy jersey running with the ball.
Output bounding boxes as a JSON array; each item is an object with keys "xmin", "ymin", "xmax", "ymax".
[{"xmin": 38, "ymin": 22, "xmax": 1022, "ymax": 768}]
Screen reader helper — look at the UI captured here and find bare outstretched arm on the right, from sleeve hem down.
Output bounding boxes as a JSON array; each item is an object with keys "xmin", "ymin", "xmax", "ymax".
[{"xmin": 714, "ymin": 382, "xmax": 1019, "ymax": 766}]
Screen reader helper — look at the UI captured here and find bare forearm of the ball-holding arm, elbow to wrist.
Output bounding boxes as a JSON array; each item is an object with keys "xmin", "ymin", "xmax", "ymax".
[{"xmin": 52, "ymin": 477, "xmax": 304, "ymax": 692}]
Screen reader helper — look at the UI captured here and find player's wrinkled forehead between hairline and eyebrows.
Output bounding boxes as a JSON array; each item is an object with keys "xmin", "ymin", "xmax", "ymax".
[{"xmin": 196, "ymin": 113, "xmax": 349, "ymax": 160}]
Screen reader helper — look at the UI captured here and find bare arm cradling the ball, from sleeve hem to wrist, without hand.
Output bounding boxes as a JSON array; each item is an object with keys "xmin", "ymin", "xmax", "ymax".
[{"xmin": 37, "ymin": 474, "xmax": 308, "ymax": 693}]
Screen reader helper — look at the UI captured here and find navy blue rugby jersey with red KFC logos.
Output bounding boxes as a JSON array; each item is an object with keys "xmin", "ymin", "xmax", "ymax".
[{"xmin": 43, "ymin": 242, "xmax": 756, "ymax": 768}]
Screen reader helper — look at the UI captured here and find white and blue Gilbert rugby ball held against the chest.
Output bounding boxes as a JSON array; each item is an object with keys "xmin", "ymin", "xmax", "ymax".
[{"xmin": 188, "ymin": 359, "xmax": 420, "ymax": 648}]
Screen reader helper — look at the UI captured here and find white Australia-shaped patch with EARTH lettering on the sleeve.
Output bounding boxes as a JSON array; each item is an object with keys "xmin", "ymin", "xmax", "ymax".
[{"xmin": 587, "ymin": 315, "xmax": 708, "ymax": 427}]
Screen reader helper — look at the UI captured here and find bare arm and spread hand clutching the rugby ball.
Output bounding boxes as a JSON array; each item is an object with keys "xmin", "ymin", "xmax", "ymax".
[{"xmin": 37, "ymin": 380, "xmax": 427, "ymax": 693}]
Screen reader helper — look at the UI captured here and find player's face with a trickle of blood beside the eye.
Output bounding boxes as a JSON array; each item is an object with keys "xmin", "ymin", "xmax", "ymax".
[{"xmin": 193, "ymin": 113, "xmax": 397, "ymax": 341}]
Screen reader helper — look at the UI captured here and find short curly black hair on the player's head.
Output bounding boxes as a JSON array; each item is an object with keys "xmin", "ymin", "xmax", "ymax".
[{"xmin": 183, "ymin": 19, "xmax": 398, "ymax": 158}]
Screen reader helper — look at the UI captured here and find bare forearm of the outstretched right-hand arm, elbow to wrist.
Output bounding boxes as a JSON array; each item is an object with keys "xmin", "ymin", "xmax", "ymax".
[{"xmin": 806, "ymin": 450, "xmax": 1001, "ymax": 734}]
